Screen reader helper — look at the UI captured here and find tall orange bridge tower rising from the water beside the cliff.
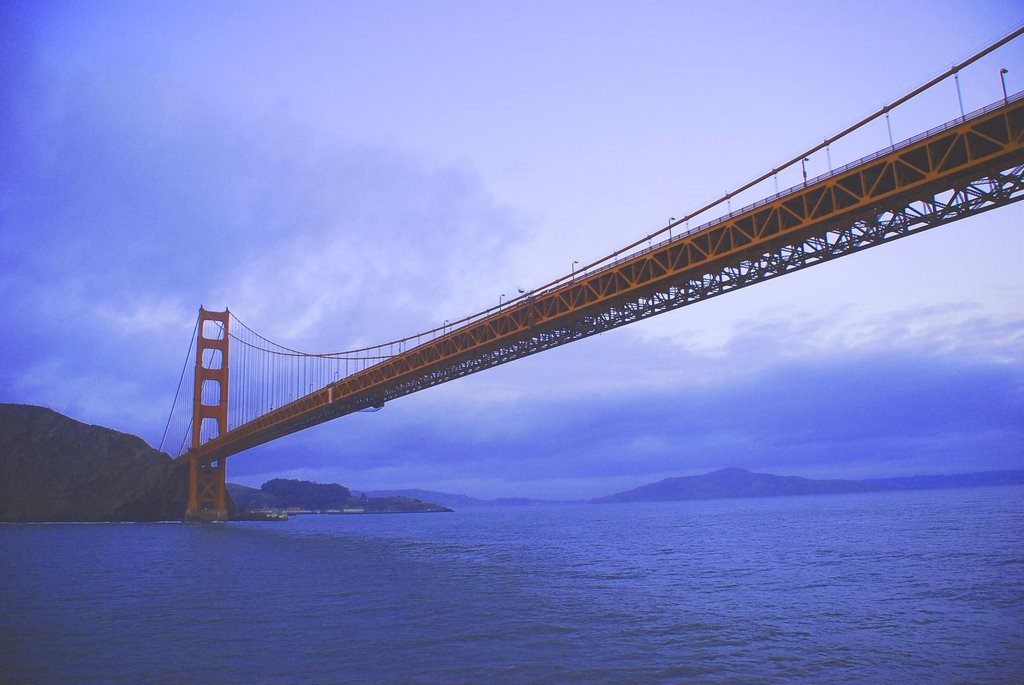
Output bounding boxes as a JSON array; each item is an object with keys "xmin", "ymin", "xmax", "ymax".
[{"xmin": 185, "ymin": 307, "xmax": 230, "ymax": 521}]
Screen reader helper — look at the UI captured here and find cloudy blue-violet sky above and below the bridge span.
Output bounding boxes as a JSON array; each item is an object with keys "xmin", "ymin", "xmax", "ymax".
[{"xmin": 0, "ymin": 0, "xmax": 1024, "ymax": 498}]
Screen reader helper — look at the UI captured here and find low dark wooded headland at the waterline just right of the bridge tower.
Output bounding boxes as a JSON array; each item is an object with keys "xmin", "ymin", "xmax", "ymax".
[{"xmin": 227, "ymin": 478, "xmax": 452, "ymax": 514}]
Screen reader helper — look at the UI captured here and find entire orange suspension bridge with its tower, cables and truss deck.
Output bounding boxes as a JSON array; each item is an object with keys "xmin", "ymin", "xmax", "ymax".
[{"xmin": 161, "ymin": 28, "xmax": 1024, "ymax": 520}]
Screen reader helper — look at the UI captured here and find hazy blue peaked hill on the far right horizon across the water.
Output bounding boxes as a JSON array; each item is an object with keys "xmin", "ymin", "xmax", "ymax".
[{"xmin": 591, "ymin": 468, "xmax": 1024, "ymax": 503}]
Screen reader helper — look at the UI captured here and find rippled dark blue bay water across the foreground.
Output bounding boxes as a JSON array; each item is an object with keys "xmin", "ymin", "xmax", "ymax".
[{"xmin": 0, "ymin": 486, "xmax": 1024, "ymax": 684}]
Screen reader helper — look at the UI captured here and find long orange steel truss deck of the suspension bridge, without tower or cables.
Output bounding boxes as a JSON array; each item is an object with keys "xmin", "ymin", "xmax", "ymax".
[{"xmin": 184, "ymin": 96, "xmax": 1024, "ymax": 464}]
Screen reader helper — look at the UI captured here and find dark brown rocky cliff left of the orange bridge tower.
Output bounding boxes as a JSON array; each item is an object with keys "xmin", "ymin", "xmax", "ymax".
[{"xmin": 0, "ymin": 404, "xmax": 205, "ymax": 521}]
